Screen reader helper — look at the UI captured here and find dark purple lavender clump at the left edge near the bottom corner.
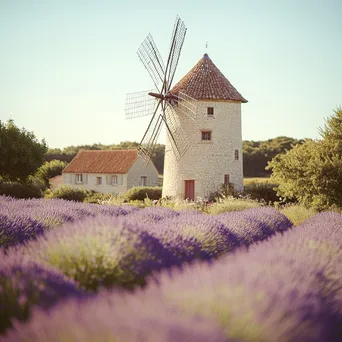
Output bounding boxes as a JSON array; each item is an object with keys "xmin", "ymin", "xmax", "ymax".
[{"xmin": 0, "ymin": 251, "xmax": 84, "ymax": 333}]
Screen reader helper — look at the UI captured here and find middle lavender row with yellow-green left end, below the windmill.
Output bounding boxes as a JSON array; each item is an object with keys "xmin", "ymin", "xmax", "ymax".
[{"xmin": 12, "ymin": 208, "xmax": 292, "ymax": 290}]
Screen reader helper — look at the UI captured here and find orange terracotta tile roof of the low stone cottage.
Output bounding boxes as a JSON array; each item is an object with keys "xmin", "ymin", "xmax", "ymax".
[{"xmin": 63, "ymin": 150, "xmax": 138, "ymax": 173}]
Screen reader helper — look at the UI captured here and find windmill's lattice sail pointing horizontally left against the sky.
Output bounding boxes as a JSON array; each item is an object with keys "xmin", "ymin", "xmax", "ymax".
[{"xmin": 125, "ymin": 90, "xmax": 157, "ymax": 119}]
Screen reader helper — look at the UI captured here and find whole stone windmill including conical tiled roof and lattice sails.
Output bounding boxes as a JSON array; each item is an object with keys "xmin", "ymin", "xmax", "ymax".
[{"xmin": 125, "ymin": 18, "xmax": 247, "ymax": 200}]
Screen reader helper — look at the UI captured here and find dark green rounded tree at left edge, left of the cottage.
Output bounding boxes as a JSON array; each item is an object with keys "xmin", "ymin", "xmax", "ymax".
[{"xmin": 0, "ymin": 120, "xmax": 47, "ymax": 182}]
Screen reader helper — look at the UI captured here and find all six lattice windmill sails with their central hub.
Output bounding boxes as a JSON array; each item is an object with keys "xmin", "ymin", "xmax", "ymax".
[{"xmin": 125, "ymin": 17, "xmax": 197, "ymax": 165}]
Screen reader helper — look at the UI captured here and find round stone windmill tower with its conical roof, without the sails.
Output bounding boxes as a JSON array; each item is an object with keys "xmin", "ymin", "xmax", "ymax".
[{"xmin": 163, "ymin": 54, "xmax": 247, "ymax": 199}]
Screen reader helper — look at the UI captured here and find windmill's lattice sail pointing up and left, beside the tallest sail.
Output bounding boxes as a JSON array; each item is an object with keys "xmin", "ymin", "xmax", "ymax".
[{"xmin": 137, "ymin": 34, "xmax": 165, "ymax": 91}]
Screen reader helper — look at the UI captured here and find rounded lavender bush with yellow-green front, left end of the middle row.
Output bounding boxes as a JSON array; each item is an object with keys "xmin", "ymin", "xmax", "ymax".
[{"xmin": 18, "ymin": 216, "xmax": 176, "ymax": 290}]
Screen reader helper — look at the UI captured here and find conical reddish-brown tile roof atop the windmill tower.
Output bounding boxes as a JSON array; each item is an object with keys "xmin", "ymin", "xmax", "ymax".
[{"xmin": 170, "ymin": 54, "xmax": 248, "ymax": 102}]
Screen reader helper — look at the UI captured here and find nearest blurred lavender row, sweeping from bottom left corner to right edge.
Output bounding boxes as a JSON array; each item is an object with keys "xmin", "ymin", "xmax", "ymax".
[{"xmin": 4, "ymin": 213, "xmax": 342, "ymax": 342}]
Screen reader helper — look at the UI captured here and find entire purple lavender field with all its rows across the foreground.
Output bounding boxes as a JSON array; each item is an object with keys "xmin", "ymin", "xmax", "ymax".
[{"xmin": 0, "ymin": 196, "xmax": 342, "ymax": 342}]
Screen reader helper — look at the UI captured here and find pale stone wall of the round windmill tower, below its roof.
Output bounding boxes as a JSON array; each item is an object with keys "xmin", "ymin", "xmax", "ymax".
[{"xmin": 163, "ymin": 101, "xmax": 243, "ymax": 198}]
